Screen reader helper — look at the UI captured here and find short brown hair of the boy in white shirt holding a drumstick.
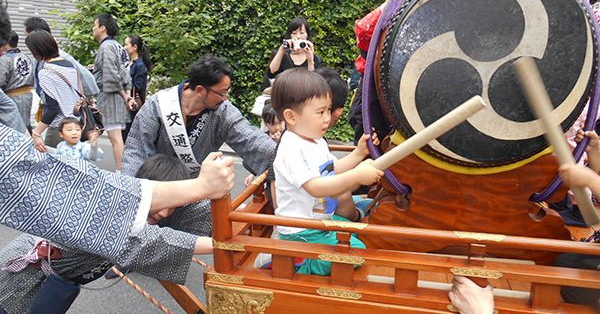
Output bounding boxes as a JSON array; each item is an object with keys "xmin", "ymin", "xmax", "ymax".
[{"xmin": 271, "ymin": 68, "xmax": 331, "ymax": 121}]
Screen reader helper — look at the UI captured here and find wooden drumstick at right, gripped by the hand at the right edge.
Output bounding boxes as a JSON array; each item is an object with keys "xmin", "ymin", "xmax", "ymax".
[{"xmin": 514, "ymin": 57, "xmax": 600, "ymax": 226}]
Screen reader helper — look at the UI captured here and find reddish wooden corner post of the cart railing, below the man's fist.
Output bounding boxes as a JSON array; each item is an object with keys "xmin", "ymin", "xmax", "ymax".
[{"xmin": 211, "ymin": 194, "xmax": 234, "ymax": 273}]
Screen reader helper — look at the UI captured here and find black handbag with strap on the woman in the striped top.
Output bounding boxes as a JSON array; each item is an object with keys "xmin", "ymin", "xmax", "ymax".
[{"xmin": 49, "ymin": 68, "xmax": 104, "ymax": 141}]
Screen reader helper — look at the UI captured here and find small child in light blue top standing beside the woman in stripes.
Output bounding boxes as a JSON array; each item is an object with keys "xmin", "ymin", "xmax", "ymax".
[{"xmin": 55, "ymin": 117, "xmax": 104, "ymax": 161}]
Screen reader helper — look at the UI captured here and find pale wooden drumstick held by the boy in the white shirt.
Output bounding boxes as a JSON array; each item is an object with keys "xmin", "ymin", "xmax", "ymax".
[{"xmin": 373, "ymin": 96, "xmax": 485, "ymax": 170}]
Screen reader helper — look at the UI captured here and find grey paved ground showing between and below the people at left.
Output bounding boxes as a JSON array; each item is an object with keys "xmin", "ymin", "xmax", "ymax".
[{"xmin": 0, "ymin": 136, "xmax": 248, "ymax": 314}]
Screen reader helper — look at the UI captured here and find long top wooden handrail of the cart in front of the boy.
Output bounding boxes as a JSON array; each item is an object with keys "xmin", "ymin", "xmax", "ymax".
[{"xmin": 229, "ymin": 212, "xmax": 600, "ymax": 255}]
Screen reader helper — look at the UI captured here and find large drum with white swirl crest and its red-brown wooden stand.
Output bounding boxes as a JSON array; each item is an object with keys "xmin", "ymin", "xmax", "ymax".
[{"xmin": 361, "ymin": 0, "xmax": 597, "ymax": 264}]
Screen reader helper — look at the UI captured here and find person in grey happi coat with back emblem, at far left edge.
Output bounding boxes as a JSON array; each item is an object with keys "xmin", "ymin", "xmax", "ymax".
[{"xmin": 0, "ymin": 31, "xmax": 34, "ymax": 129}]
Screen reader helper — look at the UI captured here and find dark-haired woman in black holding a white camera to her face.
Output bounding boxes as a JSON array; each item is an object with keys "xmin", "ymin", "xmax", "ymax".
[{"xmin": 263, "ymin": 17, "xmax": 323, "ymax": 89}]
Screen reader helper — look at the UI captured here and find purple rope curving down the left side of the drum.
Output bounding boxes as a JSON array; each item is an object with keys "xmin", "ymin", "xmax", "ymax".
[{"xmin": 362, "ymin": 0, "xmax": 410, "ymax": 195}]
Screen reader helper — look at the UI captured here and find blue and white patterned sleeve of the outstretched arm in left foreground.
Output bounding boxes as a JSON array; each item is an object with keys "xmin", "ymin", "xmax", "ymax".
[{"xmin": 0, "ymin": 125, "xmax": 141, "ymax": 258}]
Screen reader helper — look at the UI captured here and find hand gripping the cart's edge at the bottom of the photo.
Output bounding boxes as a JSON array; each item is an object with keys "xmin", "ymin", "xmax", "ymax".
[{"xmin": 448, "ymin": 276, "xmax": 494, "ymax": 314}]
